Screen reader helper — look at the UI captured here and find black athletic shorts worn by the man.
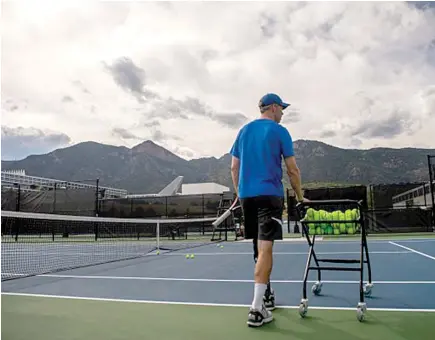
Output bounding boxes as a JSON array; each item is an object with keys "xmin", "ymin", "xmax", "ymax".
[{"xmin": 240, "ymin": 196, "xmax": 284, "ymax": 241}]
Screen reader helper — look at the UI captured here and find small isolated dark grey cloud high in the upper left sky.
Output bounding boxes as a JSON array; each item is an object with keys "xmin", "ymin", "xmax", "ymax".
[{"xmin": 106, "ymin": 57, "xmax": 159, "ymax": 103}]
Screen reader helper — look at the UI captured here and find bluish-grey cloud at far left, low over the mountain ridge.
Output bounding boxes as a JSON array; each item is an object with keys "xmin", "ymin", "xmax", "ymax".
[{"xmin": 1, "ymin": 126, "xmax": 71, "ymax": 160}]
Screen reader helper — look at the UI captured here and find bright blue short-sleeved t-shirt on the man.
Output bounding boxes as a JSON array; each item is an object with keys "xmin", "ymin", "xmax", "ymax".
[{"xmin": 230, "ymin": 119, "xmax": 294, "ymax": 198}]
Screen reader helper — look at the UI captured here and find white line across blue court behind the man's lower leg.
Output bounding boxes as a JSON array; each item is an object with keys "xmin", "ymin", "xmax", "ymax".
[{"xmin": 3, "ymin": 273, "xmax": 435, "ymax": 284}]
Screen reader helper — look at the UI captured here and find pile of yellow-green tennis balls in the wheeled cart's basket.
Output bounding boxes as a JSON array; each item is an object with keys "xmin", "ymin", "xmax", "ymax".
[{"xmin": 301, "ymin": 208, "xmax": 360, "ymax": 235}]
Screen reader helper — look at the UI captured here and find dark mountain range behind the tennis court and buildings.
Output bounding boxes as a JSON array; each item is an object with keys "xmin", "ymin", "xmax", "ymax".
[{"xmin": 2, "ymin": 140, "xmax": 435, "ymax": 193}]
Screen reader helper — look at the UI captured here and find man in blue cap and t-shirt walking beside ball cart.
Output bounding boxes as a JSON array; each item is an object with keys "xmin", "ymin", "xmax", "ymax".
[{"xmin": 231, "ymin": 93, "xmax": 304, "ymax": 327}]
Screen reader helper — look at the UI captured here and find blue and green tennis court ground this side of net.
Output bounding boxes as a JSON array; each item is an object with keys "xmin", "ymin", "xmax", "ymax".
[{"xmin": 2, "ymin": 228, "xmax": 435, "ymax": 340}]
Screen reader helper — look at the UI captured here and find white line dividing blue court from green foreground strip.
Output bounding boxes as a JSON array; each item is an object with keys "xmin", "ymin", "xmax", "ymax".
[{"xmin": 2, "ymin": 292, "xmax": 435, "ymax": 313}]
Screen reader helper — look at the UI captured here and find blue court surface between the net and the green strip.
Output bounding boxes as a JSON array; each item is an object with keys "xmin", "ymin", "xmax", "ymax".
[{"xmin": 2, "ymin": 238, "xmax": 435, "ymax": 312}]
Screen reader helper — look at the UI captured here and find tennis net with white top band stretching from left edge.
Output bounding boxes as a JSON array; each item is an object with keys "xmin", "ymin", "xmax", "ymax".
[{"xmin": 1, "ymin": 211, "xmax": 216, "ymax": 281}]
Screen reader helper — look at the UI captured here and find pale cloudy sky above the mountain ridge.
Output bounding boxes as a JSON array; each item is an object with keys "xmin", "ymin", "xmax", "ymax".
[{"xmin": 1, "ymin": 0, "xmax": 435, "ymax": 160}]
